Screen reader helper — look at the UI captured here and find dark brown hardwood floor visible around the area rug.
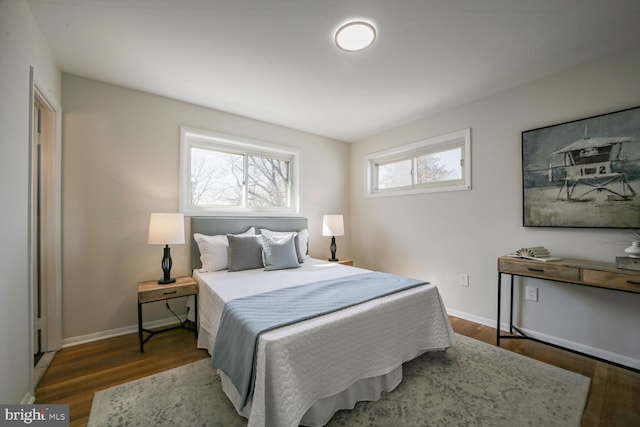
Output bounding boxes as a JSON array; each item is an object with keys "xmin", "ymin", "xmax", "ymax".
[{"xmin": 36, "ymin": 317, "xmax": 640, "ymax": 427}]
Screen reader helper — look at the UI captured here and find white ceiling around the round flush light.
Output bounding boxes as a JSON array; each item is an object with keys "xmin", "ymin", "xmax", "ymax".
[{"xmin": 27, "ymin": 0, "xmax": 640, "ymax": 142}]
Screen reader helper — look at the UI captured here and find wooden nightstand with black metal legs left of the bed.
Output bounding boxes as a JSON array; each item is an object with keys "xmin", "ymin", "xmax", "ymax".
[{"xmin": 138, "ymin": 276, "xmax": 198, "ymax": 353}]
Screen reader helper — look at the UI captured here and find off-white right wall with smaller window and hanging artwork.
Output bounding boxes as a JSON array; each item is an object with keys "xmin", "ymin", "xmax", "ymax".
[{"xmin": 350, "ymin": 46, "xmax": 640, "ymax": 366}]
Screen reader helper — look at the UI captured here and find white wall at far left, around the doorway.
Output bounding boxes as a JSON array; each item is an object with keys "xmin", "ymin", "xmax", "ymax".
[{"xmin": 0, "ymin": 0, "xmax": 61, "ymax": 403}]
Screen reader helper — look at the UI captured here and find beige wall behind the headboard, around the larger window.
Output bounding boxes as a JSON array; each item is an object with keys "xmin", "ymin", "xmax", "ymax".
[{"xmin": 62, "ymin": 74, "xmax": 349, "ymax": 343}]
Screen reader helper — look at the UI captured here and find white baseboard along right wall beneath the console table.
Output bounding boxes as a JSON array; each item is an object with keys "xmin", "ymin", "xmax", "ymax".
[{"xmin": 447, "ymin": 308, "xmax": 640, "ymax": 370}]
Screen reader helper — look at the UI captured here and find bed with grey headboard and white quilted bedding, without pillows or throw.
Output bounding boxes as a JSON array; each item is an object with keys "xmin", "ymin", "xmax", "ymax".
[{"xmin": 191, "ymin": 217, "xmax": 455, "ymax": 426}]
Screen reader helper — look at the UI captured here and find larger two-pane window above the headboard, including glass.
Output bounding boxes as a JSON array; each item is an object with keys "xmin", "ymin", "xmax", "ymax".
[{"xmin": 180, "ymin": 127, "xmax": 300, "ymax": 215}]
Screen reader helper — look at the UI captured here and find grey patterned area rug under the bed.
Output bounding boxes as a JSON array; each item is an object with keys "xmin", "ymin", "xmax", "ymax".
[{"xmin": 88, "ymin": 335, "xmax": 590, "ymax": 427}]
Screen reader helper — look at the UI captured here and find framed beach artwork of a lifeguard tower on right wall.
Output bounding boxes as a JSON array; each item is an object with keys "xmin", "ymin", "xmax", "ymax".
[{"xmin": 522, "ymin": 107, "xmax": 640, "ymax": 228}]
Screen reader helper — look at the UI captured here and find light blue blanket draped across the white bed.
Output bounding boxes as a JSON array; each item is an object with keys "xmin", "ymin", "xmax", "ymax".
[{"xmin": 211, "ymin": 272, "xmax": 428, "ymax": 407}]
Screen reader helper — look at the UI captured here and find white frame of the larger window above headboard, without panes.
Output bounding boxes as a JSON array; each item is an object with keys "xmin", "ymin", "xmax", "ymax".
[{"xmin": 179, "ymin": 126, "xmax": 302, "ymax": 216}]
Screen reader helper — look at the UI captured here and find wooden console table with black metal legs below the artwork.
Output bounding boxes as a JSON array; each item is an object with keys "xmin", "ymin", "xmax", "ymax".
[{"xmin": 496, "ymin": 256, "xmax": 640, "ymax": 370}]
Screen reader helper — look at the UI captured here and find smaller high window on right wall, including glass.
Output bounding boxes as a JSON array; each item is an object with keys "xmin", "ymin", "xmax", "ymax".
[{"xmin": 365, "ymin": 128, "xmax": 471, "ymax": 197}]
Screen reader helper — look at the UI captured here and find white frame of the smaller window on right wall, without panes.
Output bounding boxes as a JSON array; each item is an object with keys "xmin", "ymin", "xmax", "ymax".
[{"xmin": 364, "ymin": 128, "xmax": 471, "ymax": 198}]
